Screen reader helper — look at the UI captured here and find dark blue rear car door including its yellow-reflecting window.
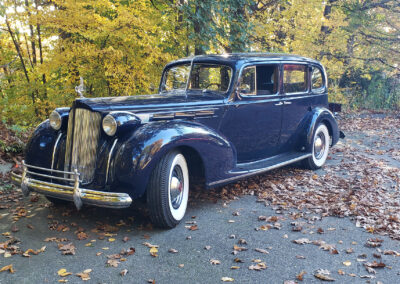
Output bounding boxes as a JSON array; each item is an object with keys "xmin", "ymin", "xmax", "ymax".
[{"xmin": 280, "ymin": 62, "xmax": 313, "ymax": 152}]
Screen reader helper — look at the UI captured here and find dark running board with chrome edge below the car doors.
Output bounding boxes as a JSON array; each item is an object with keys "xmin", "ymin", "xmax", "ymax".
[{"xmin": 208, "ymin": 153, "xmax": 312, "ymax": 187}]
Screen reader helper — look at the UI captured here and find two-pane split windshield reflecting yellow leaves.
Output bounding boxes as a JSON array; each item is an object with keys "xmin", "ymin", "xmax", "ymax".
[{"xmin": 161, "ymin": 63, "xmax": 232, "ymax": 93}]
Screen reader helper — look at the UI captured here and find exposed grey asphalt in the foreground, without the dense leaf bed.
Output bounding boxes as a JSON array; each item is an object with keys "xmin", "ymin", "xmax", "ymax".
[{"xmin": 0, "ymin": 122, "xmax": 400, "ymax": 283}]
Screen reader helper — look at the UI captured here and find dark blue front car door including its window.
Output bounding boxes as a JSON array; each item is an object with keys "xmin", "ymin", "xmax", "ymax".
[{"xmin": 220, "ymin": 63, "xmax": 283, "ymax": 163}]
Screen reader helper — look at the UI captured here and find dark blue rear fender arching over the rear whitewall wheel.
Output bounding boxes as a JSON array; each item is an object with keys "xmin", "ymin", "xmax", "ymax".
[{"xmin": 305, "ymin": 107, "xmax": 339, "ymax": 151}]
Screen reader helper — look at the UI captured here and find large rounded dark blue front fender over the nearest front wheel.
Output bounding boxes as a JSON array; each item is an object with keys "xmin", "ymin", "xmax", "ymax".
[{"xmin": 114, "ymin": 121, "xmax": 235, "ymax": 198}]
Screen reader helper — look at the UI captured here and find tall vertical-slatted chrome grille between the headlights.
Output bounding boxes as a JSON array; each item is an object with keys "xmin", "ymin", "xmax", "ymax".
[{"xmin": 64, "ymin": 108, "xmax": 101, "ymax": 184}]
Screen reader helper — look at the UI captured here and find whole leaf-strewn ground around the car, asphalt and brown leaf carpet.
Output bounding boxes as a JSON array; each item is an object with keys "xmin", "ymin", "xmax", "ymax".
[{"xmin": 0, "ymin": 113, "xmax": 400, "ymax": 283}]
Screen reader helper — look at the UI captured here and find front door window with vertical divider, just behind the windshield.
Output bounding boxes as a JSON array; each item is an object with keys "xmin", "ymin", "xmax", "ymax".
[{"xmin": 240, "ymin": 64, "xmax": 279, "ymax": 96}]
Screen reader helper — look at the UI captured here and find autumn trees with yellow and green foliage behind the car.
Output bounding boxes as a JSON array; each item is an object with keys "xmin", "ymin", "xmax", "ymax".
[{"xmin": 0, "ymin": 0, "xmax": 400, "ymax": 126}]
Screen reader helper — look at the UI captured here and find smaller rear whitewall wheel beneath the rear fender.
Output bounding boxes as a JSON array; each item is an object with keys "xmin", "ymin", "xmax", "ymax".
[{"xmin": 303, "ymin": 123, "xmax": 330, "ymax": 170}]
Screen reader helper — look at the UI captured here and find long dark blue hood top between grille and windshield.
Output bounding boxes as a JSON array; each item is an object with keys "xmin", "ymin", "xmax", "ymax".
[{"xmin": 74, "ymin": 93, "xmax": 224, "ymax": 113}]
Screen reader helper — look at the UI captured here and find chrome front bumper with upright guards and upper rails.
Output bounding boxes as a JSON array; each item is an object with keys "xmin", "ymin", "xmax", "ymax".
[{"xmin": 11, "ymin": 162, "xmax": 132, "ymax": 210}]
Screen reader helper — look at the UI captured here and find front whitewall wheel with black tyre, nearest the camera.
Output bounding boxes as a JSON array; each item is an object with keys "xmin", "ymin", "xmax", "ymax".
[{"xmin": 147, "ymin": 151, "xmax": 189, "ymax": 228}]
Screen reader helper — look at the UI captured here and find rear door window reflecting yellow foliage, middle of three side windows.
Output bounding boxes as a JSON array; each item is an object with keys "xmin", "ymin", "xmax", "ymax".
[{"xmin": 283, "ymin": 64, "xmax": 307, "ymax": 93}]
